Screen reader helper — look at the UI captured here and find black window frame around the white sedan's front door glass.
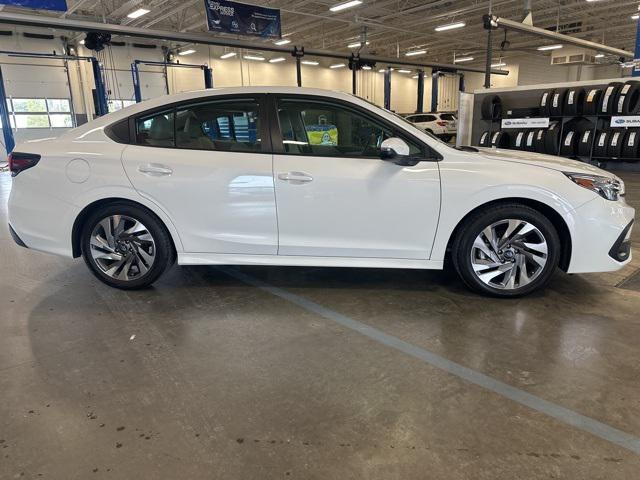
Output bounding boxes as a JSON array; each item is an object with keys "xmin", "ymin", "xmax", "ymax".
[{"xmin": 267, "ymin": 93, "xmax": 443, "ymax": 162}]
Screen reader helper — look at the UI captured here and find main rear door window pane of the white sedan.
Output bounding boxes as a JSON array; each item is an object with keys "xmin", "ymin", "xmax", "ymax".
[{"xmin": 176, "ymin": 100, "xmax": 261, "ymax": 152}]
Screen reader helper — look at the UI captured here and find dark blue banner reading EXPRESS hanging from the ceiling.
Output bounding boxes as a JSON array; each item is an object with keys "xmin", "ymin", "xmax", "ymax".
[{"xmin": 204, "ymin": 0, "xmax": 281, "ymax": 38}]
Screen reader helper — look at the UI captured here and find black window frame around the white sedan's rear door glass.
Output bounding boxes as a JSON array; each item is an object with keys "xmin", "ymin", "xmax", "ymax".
[{"xmin": 127, "ymin": 93, "xmax": 273, "ymax": 154}]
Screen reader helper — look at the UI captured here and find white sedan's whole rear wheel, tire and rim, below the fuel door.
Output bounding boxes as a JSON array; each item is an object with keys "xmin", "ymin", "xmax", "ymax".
[{"xmin": 81, "ymin": 203, "xmax": 173, "ymax": 289}]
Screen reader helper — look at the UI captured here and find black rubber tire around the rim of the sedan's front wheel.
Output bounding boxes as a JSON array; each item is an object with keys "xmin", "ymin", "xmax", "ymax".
[{"xmin": 451, "ymin": 203, "xmax": 561, "ymax": 298}]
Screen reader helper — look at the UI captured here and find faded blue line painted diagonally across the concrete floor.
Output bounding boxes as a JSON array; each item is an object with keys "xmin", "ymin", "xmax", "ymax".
[{"xmin": 220, "ymin": 267, "xmax": 640, "ymax": 454}]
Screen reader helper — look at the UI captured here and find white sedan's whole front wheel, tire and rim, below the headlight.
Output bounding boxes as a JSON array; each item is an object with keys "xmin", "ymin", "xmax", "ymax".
[{"xmin": 452, "ymin": 204, "xmax": 561, "ymax": 297}]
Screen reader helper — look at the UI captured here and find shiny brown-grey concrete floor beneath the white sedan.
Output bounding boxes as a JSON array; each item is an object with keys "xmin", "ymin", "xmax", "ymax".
[{"xmin": 0, "ymin": 173, "xmax": 640, "ymax": 480}]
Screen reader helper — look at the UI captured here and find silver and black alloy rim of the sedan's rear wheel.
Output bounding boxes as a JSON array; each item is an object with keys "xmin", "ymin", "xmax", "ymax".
[{"xmin": 90, "ymin": 215, "xmax": 156, "ymax": 281}]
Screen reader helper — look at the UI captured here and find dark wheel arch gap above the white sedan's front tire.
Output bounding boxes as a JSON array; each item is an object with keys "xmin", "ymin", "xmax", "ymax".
[{"xmin": 446, "ymin": 197, "xmax": 573, "ymax": 272}]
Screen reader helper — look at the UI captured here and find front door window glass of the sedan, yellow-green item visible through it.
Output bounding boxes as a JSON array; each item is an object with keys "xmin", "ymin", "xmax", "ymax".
[{"xmin": 278, "ymin": 99, "xmax": 422, "ymax": 158}]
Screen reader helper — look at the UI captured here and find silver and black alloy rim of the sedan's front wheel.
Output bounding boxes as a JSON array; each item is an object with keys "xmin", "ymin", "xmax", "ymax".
[{"xmin": 471, "ymin": 218, "xmax": 549, "ymax": 290}]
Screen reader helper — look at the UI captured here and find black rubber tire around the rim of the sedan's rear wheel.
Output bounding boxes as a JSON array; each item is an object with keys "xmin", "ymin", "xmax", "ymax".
[{"xmin": 80, "ymin": 202, "xmax": 175, "ymax": 290}]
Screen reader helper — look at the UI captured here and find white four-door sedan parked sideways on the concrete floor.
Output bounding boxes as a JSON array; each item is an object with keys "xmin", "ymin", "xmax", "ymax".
[{"xmin": 9, "ymin": 87, "xmax": 635, "ymax": 296}]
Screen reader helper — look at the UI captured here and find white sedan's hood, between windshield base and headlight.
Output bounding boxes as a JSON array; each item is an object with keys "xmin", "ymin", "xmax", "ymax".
[{"xmin": 475, "ymin": 147, "xmax": 617, "ymax": 178}]
